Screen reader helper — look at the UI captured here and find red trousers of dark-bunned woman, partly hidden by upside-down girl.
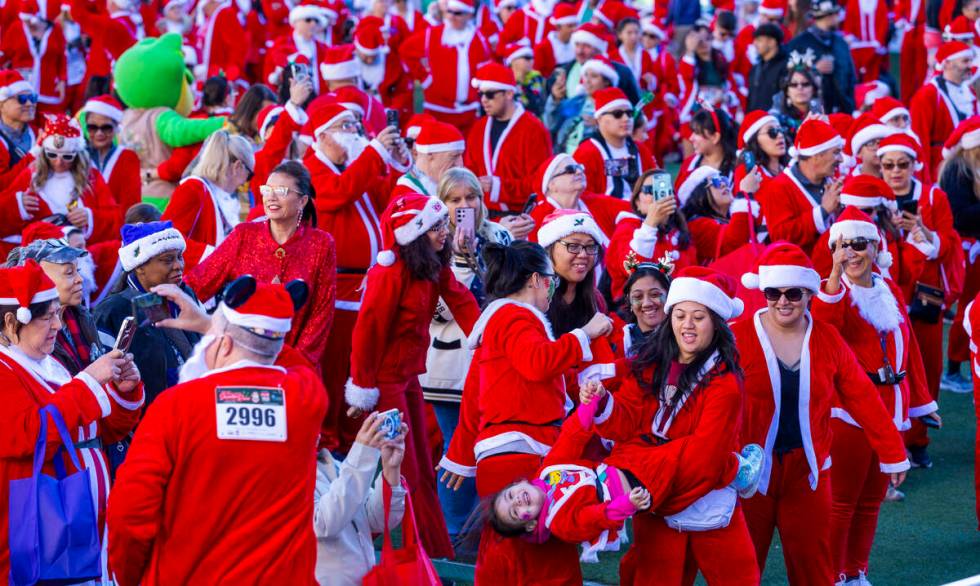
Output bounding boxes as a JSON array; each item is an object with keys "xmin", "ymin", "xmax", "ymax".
[{"xmin": 474, "ymin": 454, "xmax": 582, "ymax": 586}]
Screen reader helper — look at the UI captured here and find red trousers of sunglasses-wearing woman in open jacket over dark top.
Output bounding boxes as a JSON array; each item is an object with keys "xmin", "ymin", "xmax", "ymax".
[{"xmin": 742, "ymin": 448, "xmax": 836, "ymax": 586}]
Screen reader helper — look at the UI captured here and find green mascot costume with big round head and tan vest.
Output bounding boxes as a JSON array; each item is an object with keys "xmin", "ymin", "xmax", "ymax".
[{"xmin": 113, "ymin": 33, "xmax": 225, "ymax": 205}]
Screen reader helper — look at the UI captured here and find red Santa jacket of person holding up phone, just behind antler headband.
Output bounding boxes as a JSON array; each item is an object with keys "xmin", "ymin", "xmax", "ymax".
[{"xmin": 605, "ymin": 214, "xmax": 698, "ymax": 300}]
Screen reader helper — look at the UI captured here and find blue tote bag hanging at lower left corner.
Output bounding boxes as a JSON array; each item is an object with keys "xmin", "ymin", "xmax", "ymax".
[{"xmin": 9, "ymin": 405, "xmax": 102, "ymax": 585}]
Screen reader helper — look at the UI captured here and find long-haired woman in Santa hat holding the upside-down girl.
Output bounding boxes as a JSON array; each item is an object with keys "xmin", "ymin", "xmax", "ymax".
[{"xmin": 595, "ymin": 267, "xmax": 759, "ymax": 585}]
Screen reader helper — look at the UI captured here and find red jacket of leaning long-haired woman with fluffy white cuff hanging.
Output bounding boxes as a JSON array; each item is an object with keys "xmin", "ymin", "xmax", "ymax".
[{"xmin": 345, "ymin": 258, "xmax": 480, "ymax": 410}]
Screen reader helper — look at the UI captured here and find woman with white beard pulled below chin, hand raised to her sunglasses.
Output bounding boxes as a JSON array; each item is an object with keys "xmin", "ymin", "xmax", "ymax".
[{"xmin": 813, "ymin": 206, "xmax": 941, "ymax": 580}]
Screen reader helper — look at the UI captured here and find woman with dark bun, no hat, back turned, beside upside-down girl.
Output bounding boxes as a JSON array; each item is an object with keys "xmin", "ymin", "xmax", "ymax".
[{"xmin": 439, "ymin": 241, "xmax": 612, "ymax": 585}]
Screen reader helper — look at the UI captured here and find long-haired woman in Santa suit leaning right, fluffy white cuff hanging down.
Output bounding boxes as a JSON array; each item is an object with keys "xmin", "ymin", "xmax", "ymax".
[{"xmin": 345, "ymin": 193, "xmax": 480, "ymax": 557}]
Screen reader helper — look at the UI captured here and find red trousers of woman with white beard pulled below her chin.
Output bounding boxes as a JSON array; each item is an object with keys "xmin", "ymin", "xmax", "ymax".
[{"xmin": 830, "ymin": 419, "xmax": 889, "ymax": 576}]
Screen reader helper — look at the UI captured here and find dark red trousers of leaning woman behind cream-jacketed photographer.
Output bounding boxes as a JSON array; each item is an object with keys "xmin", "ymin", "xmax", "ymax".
[{"xmin": 377, "ymin": 376, "xmax": 453, "ymax": 558}]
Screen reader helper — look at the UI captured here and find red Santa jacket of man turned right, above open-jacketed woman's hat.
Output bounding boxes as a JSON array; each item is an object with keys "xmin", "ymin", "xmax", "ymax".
[{"xmin": 756, "ymin": 167, "xmax": 829, "ymax": 254}]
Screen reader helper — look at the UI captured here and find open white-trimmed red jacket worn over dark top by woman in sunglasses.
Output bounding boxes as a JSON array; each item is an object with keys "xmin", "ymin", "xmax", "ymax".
[{"xmin": 732, "ymin": 309, "xmax": 909, "ymax": 494}]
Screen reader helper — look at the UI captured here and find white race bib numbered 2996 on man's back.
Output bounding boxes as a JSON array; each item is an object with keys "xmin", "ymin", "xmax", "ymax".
[{"xmin": 215, "ymin": 387, "xmax": 286, "ymax": 442}]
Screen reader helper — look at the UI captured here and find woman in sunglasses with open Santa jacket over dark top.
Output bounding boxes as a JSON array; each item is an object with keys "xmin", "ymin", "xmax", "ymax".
[{"xmin": 732, "ymin": 242, "xmax": 909, "ymax": 586}]
